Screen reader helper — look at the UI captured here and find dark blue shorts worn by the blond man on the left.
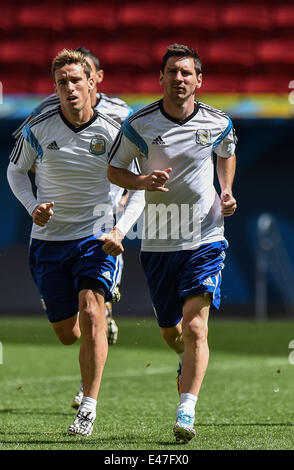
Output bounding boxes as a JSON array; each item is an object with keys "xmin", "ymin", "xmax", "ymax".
[{"xmin": 29, "ymin": 236, "xmax": 120, "ymax": 322}]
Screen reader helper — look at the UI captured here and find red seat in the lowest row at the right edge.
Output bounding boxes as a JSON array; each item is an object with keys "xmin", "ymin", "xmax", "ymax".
[{"xmin": 242, "ymin": 74, "xmax": 289, "ymax": 94}]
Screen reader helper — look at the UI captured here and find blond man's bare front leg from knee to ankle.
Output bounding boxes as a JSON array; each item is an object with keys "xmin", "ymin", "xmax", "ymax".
[{"xmin": 79, "ymin": 289, "xmax": 108, "ymax": 400}]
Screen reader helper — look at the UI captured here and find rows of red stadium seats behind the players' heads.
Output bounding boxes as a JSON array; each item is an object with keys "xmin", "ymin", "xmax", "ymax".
[{"xmin": 0, "ymin": 0, "xmax": 294, "ymax": 94}]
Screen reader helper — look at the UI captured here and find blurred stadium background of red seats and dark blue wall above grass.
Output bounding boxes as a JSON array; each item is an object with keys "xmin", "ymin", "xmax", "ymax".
[{"xmin": 0, "ymin": 0, "xmax": 294, "ymax": 320}]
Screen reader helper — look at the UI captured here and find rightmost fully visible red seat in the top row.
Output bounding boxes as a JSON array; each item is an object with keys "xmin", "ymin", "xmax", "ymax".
[{"xmin": 220, "ymin": 2, "xmax": 272, "ymax": 35}]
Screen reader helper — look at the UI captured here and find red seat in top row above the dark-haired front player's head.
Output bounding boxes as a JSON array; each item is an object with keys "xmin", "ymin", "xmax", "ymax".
[{"xmin": 168, "ymin": 2, "xmax": 220, "ymax": 36}]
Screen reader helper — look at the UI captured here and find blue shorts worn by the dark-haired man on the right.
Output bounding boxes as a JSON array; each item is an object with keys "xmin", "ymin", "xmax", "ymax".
[{"xmin": 140, "ymin": 241, "xmax": 228, "ymax": 328}]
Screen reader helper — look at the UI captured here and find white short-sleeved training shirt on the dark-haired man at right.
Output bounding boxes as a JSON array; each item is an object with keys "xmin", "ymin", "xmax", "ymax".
[{"xmin": 109, "ymin": 100, "xmax": 236, "ymax": 251}]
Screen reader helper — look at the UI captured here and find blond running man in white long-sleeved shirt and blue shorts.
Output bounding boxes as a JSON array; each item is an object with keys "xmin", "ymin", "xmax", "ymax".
[{"xmin": 8, "ymin": 50, "xmax": 144, "ymax": 436}]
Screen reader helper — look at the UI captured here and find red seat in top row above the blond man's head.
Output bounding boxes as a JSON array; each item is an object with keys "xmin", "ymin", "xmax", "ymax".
[{"xmin": 66, "ymin": 3, "xmax": 117, "ymax": 31}]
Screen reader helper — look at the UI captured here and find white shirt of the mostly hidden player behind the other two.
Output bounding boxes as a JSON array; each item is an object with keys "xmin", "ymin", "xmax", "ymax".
[{"xmin": 13, "ymin": 93, "xmax": 133, "ymax": 139}]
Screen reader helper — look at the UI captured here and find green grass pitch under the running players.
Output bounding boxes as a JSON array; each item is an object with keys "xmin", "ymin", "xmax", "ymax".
[{"xmin": 0, "ymin": 317, "xmax": 294, "ymax": 451}]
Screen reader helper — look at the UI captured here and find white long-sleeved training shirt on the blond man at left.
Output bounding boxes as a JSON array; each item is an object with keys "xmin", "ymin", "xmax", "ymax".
[{"xmin": 8, "ymin": 106, "xmax": 144, "ymax": 241}]
